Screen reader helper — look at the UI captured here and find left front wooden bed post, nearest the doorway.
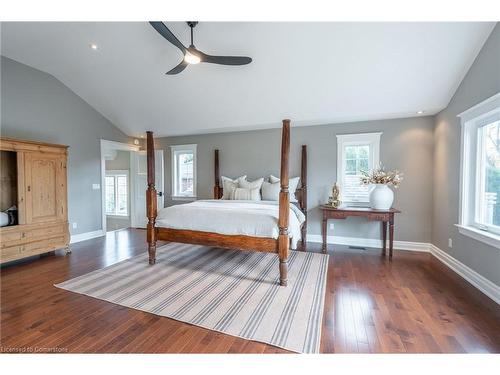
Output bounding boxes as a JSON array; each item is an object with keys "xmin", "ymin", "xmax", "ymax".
[{"xmin": 146, "ymin": 131, "xmax": 157, "ymax": 264}]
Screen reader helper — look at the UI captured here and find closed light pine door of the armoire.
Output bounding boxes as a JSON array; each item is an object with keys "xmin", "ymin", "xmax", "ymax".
[{"xmin": 24, "ymin": 152, "xmax": 66, "ymax": 224}]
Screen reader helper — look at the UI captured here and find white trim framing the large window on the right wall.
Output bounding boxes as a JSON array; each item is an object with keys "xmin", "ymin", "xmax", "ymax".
[{"xmin": 455, "ymin": 93, "xmax": 500, "ymax": 249}]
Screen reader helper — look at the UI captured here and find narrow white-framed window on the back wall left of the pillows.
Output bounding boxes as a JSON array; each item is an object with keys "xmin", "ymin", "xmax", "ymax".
[{"xmin": 170, "ymin": 145, "xmax": 196, "ymax": 199}]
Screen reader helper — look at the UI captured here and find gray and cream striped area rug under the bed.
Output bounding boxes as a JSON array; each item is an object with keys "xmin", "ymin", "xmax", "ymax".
[{"xmin": 55, "ymin": 243, "xmax": 328, "ymax": 353}]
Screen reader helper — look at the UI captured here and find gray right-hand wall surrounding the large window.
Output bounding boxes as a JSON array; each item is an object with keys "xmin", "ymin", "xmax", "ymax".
[{"xmin": 432, "ymin": 24, "xmax": 500, "ymax": 285}]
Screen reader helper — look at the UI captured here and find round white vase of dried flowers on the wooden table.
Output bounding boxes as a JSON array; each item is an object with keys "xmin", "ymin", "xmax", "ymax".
[{"xmin": 361, "ymin": 165, "xmax": 403, "ymax": 210}]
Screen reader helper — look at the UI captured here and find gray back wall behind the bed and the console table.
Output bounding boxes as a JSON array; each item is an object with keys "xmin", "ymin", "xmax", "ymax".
[{"xmin": 156, "ymin": 117, "xmax": 434, "ymax": 242}]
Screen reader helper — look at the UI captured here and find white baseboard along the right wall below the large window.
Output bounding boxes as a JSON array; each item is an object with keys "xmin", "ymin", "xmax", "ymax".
[{"xmin": 431, "ymin": 245, "xmax": 500, "ymax": 305}]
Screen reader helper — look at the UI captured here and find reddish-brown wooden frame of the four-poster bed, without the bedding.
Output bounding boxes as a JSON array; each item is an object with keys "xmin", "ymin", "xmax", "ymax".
[{"xmin": 146, "ymin": 120, "xmax": 307, "ymax": 286}]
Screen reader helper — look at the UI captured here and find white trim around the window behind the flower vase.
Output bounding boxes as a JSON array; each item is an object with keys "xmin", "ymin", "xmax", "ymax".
[{"xmin": 337, "ymin": 132, "xmax": 382, "ymax": 206}]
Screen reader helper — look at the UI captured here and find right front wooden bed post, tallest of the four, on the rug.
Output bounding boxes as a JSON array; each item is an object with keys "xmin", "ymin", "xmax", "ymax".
[{"xmin": 278, "ymin": 120, "xmax": 290, "ymax": 286}]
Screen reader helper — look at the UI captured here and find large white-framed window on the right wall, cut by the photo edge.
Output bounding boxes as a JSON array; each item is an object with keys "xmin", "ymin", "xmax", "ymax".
[{"xmin": 458, "ymin": 94, "xmax": 500, "ymax": 247}]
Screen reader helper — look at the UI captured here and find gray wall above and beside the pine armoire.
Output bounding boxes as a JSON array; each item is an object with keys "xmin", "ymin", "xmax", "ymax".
[{"xmin": 0, "ymin": 56, "xmax": 129, "ymax": 234}]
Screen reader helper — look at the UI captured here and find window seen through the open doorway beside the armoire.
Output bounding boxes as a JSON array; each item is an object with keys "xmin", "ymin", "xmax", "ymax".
[{"xmin": 105, "ymin": 171, "xmax": 129, "ymax": 216}]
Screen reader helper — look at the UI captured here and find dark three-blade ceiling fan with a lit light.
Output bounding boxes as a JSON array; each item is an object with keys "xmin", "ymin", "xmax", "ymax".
[{"xmin": 150, "ymin": 21, "xmax": 252, "ymax": 74}]
